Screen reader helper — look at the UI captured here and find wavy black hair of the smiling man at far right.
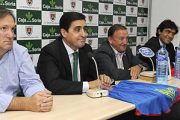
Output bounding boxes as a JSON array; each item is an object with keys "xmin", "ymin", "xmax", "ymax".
[{"xmin": 156, "ymin": 19, "xmax": 179, "ymax": 37}]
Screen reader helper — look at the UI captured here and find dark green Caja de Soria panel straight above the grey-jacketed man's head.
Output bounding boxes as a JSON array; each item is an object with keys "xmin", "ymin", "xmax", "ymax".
[{"xmin": 113, "ymin": 5, "xmax": 126, "ymax": 16}]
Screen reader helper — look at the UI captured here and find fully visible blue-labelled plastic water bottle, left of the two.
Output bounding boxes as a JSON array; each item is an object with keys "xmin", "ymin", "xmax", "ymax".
[{"xmin": 156, "ymin": 46, "xmax": 169, "ymax": 85}]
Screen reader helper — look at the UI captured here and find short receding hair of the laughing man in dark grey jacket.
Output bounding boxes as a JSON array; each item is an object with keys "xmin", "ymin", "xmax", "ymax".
[{"xmin": 108, "ymin": 24, "xmax": 127, "ymax": 37}]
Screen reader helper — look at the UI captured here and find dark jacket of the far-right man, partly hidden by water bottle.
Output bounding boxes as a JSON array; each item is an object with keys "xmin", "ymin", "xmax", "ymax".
[{"xmin": 139, "ymin": 37, "xmax": 175, "ymax": 70}]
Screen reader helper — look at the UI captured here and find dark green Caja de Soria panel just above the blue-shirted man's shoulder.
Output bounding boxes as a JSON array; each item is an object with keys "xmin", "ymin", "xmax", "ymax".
[{"xmin": 17, "ymin": 40, "xmax": 41, "ymax": 54}]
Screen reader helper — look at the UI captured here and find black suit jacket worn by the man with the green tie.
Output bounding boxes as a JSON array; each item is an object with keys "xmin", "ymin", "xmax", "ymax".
[{"xmin": 37, "ymin": 37, "xmax": 97, "ymax": 94}]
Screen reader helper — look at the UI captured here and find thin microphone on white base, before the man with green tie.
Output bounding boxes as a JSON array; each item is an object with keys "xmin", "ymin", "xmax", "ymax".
[{"xmin": 86, "ymin": 52, "xmax": 109, "ymax": 98}]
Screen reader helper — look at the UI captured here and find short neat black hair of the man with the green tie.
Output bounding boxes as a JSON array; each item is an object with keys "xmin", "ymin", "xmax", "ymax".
[{"xmin": 59, "ymin": 12, "xmax": 85, "ymax": 36}]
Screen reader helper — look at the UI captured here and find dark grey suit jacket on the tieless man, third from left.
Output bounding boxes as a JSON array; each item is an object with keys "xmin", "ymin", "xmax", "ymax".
[{"xmin": 94, "ymin": 41, "xmax": 148, "ymax": 80}]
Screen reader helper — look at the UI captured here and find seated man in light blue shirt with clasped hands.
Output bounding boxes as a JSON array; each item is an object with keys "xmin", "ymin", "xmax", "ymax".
[{"xmin": 0, "ymin": 7, "xmax": 53, "ymax": 112}]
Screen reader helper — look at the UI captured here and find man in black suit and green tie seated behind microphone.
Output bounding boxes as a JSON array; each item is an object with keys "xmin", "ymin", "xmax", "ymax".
[{"xmin": 37, "ymin": 12, "xmax": 112, "ymax": 94}]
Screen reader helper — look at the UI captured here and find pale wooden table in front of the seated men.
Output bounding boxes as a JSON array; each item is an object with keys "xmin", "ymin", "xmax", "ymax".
[{"xmin": 0, "ymin": 79, "xmax": 180, "ymax": 120}]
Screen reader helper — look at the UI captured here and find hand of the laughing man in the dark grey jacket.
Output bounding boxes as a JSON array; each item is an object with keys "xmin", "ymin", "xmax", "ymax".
[{"xmin": 128, "ymin": 65, "xmax": 142, "ymax": 79}]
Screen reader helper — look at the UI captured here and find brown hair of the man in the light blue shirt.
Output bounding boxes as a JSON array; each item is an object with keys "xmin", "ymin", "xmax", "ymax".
[{"xmin": 0, "ymin": 7, "xmax": 15, "ymax": 22}]
